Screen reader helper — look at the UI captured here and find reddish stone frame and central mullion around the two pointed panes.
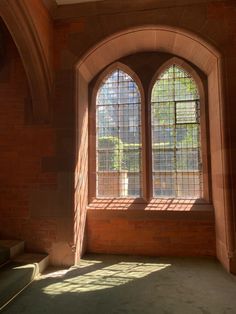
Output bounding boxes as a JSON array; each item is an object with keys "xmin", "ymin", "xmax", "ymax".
[{"xmin": 88, "ymin": 57, "xmax": 211, "ymax": 204}]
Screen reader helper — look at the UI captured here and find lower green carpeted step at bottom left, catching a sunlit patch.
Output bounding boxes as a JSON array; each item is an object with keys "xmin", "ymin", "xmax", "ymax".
[{"xmin": 0, "ymin": 253, "xmax": 48, "ymax": 311}]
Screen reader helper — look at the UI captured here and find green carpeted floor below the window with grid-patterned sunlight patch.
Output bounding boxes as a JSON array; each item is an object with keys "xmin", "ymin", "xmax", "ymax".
[{"xmin": 3, "ymin": 256, "xmax": 236, "ymax": 314}]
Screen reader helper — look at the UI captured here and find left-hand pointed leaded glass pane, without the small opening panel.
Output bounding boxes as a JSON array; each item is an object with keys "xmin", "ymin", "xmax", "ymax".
[{"xmin": 96, "ymin": 69, "xmax": 142, "ymax": 197}]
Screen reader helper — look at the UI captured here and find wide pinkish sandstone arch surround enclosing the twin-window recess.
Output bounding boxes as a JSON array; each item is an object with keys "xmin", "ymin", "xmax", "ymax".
[{"xmin": 74, "ymin": 26, "xmax": 234, "ymax": 270}]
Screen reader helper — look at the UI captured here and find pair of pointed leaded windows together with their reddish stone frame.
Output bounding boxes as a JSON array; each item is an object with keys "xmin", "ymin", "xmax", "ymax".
[{"xmin": 89, "ymin": 58, "xmax": 206, "ymax": 204}]
